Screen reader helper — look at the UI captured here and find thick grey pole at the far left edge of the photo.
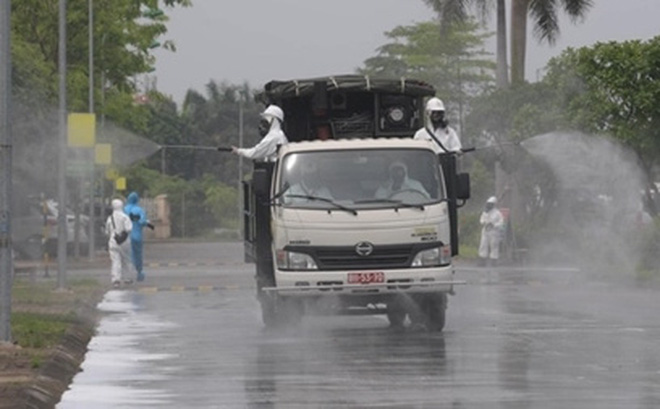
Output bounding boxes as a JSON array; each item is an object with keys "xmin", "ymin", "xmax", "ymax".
[{"xmin": 0, "ymin": 0, "xmax": 14, "ymax": 342}]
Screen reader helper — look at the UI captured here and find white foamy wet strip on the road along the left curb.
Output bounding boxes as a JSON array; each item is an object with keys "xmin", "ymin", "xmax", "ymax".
[{"xmin": 56, "ymin": 290, "xmax": 176, "ymax": 409}]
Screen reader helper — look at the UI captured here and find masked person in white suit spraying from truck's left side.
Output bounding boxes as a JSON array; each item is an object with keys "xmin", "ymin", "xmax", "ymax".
[{"xmin": 231, "ymin": 105, "xmax": 289, "ymax": 162}]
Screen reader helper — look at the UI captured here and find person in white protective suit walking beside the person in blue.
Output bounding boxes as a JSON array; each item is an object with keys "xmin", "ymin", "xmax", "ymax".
[{"xmin": 105, "ymin": 199, "xmax": 133, "ymax": 288}]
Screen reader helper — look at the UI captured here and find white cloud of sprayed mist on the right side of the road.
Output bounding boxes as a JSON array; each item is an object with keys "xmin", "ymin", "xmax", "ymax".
[{"xmin": 517, "ymin": 133, "xmax": 644, "ymax": 276}]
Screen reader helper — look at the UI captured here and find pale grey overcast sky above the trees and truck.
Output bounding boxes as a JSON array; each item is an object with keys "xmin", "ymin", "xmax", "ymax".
[{"xmin": 155, "ymin": 0, "xmax": 660, "ymax": 102}]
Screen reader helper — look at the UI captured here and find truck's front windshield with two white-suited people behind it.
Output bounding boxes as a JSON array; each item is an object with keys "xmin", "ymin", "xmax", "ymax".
[{"xmin": 277, "ymin": 149, "xmax": 445, "ymax": 210}]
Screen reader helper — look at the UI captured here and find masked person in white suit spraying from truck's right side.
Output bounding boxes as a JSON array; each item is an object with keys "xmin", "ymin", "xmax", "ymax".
[{"xmin": 413, "ymin": 97, "xmax": 462, "ymax": 153}]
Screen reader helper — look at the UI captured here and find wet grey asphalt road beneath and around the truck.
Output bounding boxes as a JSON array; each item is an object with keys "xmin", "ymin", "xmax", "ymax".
[{"xmin": 57, "ymin": 243, "xmax": 660, "ymax": 409}]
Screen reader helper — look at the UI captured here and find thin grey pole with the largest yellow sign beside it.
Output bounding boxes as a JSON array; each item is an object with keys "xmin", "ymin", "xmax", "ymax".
[{"xmin": 57, "ymin": 0, "xmax": 67, "ymax": 290}]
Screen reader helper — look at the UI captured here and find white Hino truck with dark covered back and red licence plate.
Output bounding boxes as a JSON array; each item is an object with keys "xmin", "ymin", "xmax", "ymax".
[{"xmin": 243, "ymin": 76, "xmax": 469, "ymax": 331}]
